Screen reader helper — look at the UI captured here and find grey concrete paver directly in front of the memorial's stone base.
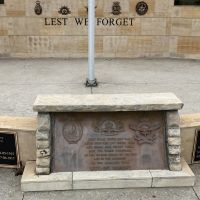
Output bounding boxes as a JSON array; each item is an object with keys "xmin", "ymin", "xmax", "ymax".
[{"xmin": 24, "ymin": 188, "xmax": 198, "ymax": 200}]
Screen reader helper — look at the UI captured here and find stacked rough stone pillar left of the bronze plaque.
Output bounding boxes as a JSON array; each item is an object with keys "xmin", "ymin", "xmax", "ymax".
[{"xmin": 36, "ymin": 113, "xmax": 51, "ymax": 175}]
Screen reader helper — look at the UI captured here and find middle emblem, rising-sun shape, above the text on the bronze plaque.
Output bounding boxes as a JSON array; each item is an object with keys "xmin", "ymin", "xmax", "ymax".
[{"xmin": 94, "ymin": 120, "xmax": 124, "ymax": 136}]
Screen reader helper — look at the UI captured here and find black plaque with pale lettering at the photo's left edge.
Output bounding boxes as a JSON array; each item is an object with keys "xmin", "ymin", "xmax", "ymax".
[{"xmin": 0, "ymin": 131, "xmax": 20, "ymax": 168}]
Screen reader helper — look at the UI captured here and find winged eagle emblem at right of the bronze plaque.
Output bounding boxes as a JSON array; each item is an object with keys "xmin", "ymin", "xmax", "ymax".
[{"xmin": 129, "ymin": 121, "xmax": 161, "ymax": 144}]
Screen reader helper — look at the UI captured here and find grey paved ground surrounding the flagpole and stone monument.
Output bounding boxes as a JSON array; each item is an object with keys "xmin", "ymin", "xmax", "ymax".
[{"xmin": 0, "ymin": 59, "xmax": 200, "ymax": 200}]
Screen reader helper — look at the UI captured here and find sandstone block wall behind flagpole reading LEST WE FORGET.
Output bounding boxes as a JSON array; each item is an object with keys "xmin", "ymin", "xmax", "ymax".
[{"xmin": 0, "ymin": 0, "xmax": 200, "ymax": 59}]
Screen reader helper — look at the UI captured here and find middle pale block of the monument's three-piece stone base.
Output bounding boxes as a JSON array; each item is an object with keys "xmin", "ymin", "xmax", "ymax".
[{"xmin": 73, "ymin": 170, "xmax": 152, "ymax": 189}]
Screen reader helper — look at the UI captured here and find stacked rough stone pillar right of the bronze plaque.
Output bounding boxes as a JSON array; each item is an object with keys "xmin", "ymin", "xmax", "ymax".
[{"xmin": 166, "ymin": 111, "xmax": 182, "ymax": 171}]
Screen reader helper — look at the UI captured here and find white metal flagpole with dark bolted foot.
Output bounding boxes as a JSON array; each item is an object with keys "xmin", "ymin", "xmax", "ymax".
[{"xmin": 86, "ymin": 0, "xmax": 98, "ymax": 87}]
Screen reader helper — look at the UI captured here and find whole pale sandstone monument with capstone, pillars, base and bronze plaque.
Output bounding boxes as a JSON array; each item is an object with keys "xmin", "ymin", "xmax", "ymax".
[{"xmin": 21, "ymin": 93, "xmax": 194, "ymax": 191}]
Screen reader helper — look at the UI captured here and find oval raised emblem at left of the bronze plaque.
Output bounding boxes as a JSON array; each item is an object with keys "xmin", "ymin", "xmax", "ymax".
[{"xmin": 63, "ymin": 119, "xmax": 83, "ymax": 144}]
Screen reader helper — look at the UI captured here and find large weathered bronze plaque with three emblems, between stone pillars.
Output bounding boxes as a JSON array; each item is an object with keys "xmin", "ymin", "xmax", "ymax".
[{"xmin": 51, "ymin": 112, "xmax": 167, "ymax": 172}]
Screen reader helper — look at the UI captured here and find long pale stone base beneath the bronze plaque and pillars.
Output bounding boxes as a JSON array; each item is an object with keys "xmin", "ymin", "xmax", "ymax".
[{"xmin": 21, "ymin": 160, "xmax": 195, "ymax": 192}]
